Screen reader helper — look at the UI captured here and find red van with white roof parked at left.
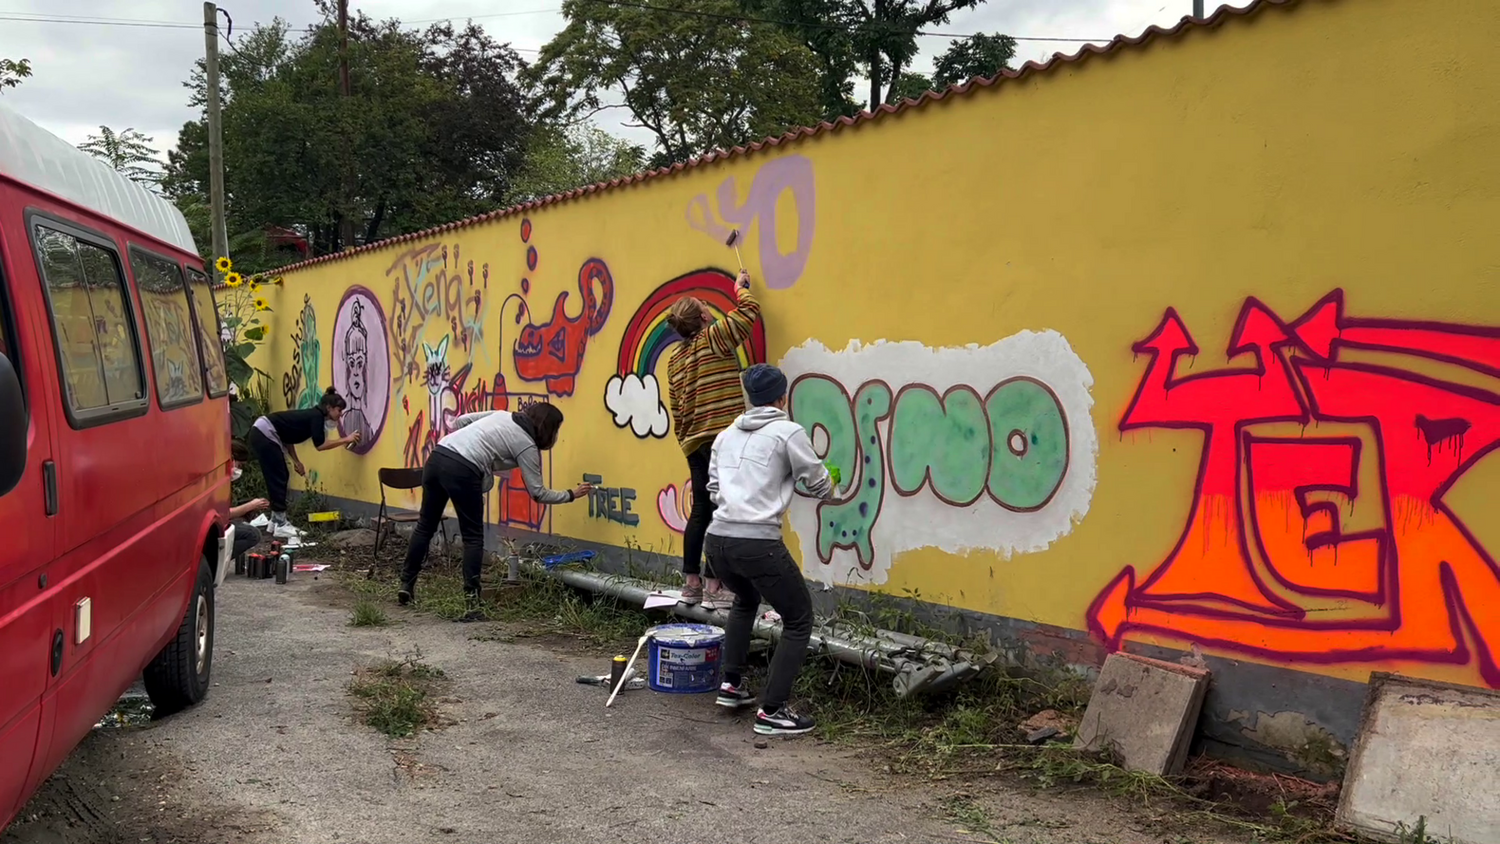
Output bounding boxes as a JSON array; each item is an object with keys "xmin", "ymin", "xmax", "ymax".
[{"xmin": 0, "ymin": 106, "xmax": 233, "ymax": 829}]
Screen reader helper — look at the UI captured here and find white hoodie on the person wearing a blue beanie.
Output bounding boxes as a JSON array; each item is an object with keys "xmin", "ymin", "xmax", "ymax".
[{"xmin": 708, "ymin": 406, "xmax": 834, "ymax": 540}]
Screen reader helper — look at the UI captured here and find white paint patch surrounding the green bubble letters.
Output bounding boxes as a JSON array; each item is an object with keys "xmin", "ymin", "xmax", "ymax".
[{"xmin": 780, "ymin": 330, "xmax": 1100, "ymax": 585}]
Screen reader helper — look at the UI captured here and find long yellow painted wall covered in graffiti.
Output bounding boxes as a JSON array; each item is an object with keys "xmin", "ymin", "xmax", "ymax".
[{"xmin": 261, "ymin": 0, "xmax": 1500, "ymax": 695}]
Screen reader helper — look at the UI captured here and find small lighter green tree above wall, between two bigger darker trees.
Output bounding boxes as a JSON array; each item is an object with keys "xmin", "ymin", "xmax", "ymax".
[{"xmin": 512, "ymin": 123, "xmax": 647, "ymax": 202}]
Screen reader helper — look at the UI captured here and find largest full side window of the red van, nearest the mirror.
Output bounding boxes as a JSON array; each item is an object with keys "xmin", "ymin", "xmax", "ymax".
[{"xmin": 36, "ymin": 225, "xmax": 146, "ymax": 411}]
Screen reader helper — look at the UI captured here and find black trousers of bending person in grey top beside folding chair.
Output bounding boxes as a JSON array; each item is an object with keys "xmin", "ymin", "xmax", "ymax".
[{"xmin": 401, "ymin": 445, "xmax": 485, "ymax": 595}]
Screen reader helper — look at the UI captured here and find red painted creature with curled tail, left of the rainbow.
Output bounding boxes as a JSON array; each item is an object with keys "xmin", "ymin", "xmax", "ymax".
[{"xmin": 507, "ymin": 256, "xmax": 615, "ymax": 396}]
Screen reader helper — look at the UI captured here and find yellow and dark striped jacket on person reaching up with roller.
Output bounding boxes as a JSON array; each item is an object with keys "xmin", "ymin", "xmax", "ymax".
[{"xmin": 666, "ymin": 289, "xmax": 761, "ymax": 454}]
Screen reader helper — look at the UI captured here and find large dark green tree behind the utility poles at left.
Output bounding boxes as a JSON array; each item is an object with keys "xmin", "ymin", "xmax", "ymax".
[{"xmin": 162, "ymin": 7, "xmax": 531, "ymax": 271}]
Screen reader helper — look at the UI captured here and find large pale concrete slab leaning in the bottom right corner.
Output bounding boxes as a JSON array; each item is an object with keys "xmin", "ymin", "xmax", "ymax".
[{"xmin": 1337, "ymin": 673, "xmax": 1500, "ymax": 844}]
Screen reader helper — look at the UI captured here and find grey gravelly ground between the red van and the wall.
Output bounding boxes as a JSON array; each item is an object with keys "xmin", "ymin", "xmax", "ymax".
[{"xmin": 0, "ymin": 574, "xmax": 1227, "ymax": 844}]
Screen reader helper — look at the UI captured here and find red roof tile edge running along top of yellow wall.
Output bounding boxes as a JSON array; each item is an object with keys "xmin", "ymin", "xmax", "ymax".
[{"xmin": 267, "ymin": 0, "xmax": 1302, "ymax": 274}]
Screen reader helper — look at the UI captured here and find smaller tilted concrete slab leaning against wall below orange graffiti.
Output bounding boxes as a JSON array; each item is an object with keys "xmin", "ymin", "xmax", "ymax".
[{"xmin": 1073, "ymin": 654, "xmax": 1209, "ymax": 777}]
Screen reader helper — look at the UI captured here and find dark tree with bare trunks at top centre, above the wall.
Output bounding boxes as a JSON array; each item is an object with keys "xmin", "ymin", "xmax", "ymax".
[{"xmin": 743, "ymin": 0, "xmax": 984, "ymax": 117}]
